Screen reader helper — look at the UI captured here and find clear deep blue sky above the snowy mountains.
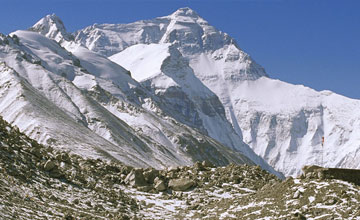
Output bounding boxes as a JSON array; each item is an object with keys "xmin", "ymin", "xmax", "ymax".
[{"xmin": 0, "ymin": 0, "xmax": 360, "ymax": 99}]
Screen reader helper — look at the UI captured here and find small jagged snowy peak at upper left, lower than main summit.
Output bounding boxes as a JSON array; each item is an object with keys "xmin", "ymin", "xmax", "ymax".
[{"xmin": 29, "ymin": 13, "xmax": 71, "ymax": 42}]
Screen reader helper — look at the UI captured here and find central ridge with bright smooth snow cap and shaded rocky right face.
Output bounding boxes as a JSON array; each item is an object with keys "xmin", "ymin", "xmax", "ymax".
[{"xmin": 110, "ymin": 44, "xmax": 272, "ymax": 170}]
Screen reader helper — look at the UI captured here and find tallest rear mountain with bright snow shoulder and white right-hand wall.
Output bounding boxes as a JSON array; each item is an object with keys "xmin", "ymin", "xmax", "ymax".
[{"xmin": 73, "ymin": 8, "xmax": 360, "ymax": 175}]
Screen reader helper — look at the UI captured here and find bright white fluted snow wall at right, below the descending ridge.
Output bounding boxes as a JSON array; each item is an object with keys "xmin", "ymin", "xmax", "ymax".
[{"xmin": 232, "ymin": 78, "xmax": 360, "ymax": 174}]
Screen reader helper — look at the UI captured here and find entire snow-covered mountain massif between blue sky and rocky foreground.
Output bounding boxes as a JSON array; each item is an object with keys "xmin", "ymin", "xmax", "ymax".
[{"xmin": 0, "ymin": 8, "xmax": 360, "ymax": 175}]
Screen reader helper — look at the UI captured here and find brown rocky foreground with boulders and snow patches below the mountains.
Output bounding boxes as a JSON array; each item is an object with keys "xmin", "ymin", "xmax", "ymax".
[{"xmin": 0, "ymin": 118, "xmax": 360, "ymax": 219}]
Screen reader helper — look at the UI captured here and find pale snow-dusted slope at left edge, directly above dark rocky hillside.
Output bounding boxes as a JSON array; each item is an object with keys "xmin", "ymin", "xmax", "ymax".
[{"xmin": 0, "ymin": 63, "xmax": 131, "ymax": 161}]
